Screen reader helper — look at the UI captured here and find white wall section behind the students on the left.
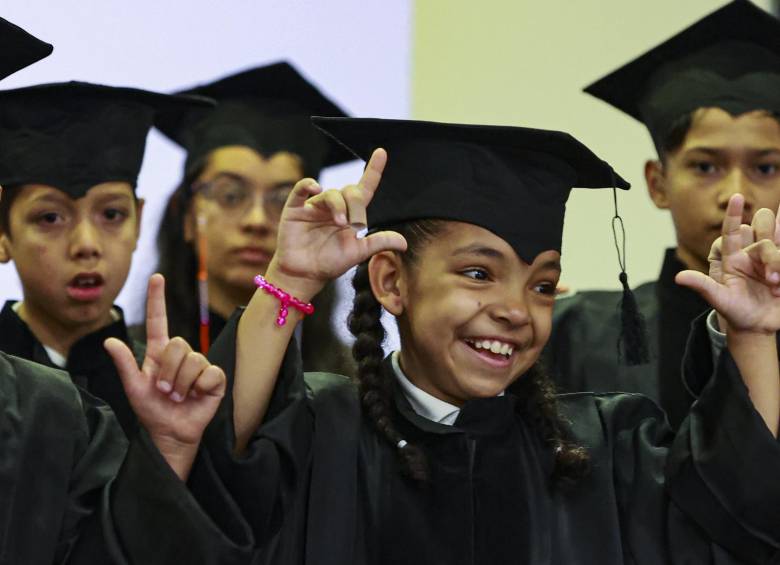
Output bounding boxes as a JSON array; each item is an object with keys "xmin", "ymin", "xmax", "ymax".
[{"xmin": 0, "ymin": 0, "xmax": 411, "ymax": 334}]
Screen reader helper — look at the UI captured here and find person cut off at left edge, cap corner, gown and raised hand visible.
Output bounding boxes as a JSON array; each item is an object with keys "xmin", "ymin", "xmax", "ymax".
[{"xmin": 0, "ymin": 18, "xmax": 247, "ymax": 565}]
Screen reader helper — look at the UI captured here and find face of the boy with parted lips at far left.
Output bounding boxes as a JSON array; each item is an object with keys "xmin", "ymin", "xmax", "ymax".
[{"xmin": 0, "ymin": 182, "xmax": 143, "ymax": 327}]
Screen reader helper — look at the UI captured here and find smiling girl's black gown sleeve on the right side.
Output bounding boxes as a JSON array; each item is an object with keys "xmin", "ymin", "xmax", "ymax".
[{"xmin": 593, "ymin": 316, "xmax": 780, "ymax": 565}]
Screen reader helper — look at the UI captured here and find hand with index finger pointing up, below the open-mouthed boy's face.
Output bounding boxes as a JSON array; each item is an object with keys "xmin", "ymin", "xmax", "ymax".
[{"xmin": 105, "ymin": 274, "xmax": 226, "ymax": 480}]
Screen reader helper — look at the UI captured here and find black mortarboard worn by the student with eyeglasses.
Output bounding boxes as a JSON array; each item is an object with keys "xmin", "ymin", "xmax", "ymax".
[{"xmin": 157, "ymin": 62, "xmax": 353, "ymax": 176}]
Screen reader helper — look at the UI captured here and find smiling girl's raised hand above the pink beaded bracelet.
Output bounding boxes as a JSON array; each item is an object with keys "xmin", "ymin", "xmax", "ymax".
[{"xmin": 268, "ymin": 149, "xmax": 406, "ymax": 300}]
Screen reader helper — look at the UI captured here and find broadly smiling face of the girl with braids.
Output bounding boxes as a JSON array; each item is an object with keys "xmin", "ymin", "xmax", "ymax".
[{"xmin": 371, "ymin": 222, "xmax": 560, "ymax": 405}]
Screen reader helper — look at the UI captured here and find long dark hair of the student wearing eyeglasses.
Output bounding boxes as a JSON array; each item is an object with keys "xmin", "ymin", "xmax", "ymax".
[{"xmin": 157, "ymin": 157, "xmax": 355, "ymax": 376}]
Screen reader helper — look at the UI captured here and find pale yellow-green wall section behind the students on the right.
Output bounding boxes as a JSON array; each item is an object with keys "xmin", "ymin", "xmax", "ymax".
[{"xmin": 411, "ymin": 0, "xmax": 769, "ymax": 289}]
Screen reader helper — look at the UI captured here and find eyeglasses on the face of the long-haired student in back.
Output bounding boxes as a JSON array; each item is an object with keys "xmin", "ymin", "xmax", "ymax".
[{"xmin": 192, "ymin": 174, "xmax": 293, "ymax": 222}]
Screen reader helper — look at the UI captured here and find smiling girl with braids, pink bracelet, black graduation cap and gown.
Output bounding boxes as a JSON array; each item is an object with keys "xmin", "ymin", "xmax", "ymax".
[{"xmin": 200, "ymin": 119, "xmax": 780, "ymax": 565}]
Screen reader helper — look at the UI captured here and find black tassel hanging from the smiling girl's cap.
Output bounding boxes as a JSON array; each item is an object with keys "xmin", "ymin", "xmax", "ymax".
[{"xmin": 612, "ymin": 181, "xmax": 650, "ymax": 367}]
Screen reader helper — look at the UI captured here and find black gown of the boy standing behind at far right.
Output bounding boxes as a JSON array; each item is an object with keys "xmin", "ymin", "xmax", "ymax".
[{"xmin": 545, "ymin": 249, "xmax": 709, "ymax": 429}]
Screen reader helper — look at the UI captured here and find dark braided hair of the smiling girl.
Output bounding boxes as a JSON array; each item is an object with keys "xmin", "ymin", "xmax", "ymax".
[{"xmin": 349, "ymin": 220, "xmax": 590, "ymax": 485}]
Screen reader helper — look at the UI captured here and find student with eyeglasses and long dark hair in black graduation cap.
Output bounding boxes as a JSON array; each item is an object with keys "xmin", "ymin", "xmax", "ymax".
[{"xmin": 147, "ymin": 62, "xmax": 353, "ymax": 372}]
